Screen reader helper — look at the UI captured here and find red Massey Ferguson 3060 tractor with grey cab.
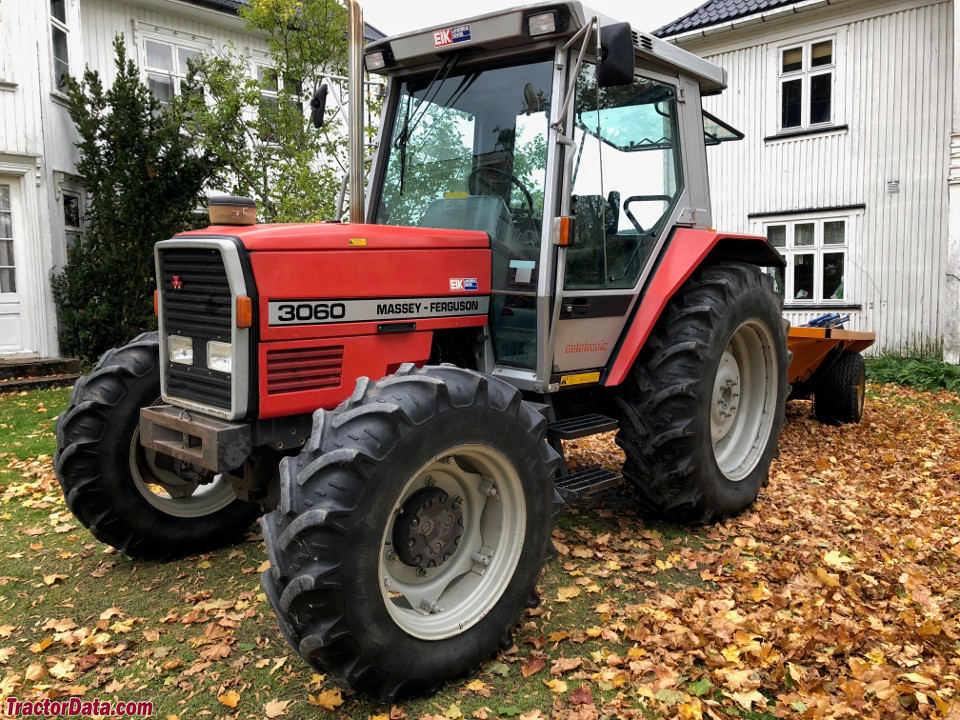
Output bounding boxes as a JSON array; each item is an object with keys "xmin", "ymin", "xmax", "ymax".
[{"xmin": 55, "ymin": 2, "xmax": 787, "ymax": 700}]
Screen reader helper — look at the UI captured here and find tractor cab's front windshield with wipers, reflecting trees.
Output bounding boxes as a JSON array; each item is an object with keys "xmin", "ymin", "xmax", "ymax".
[{"xmin": 376, "ymin": 60, "xmax": 553, "ymax": 258}]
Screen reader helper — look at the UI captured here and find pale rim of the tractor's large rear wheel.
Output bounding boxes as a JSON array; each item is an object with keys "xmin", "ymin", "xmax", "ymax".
[{"xmin": 710, "ymin": 320, "xmax": 777, "ymax": 482}]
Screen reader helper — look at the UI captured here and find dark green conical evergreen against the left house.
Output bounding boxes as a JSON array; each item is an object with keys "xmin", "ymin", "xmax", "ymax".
[{"xmin": 51, "ymin": 36, "xmax": 215, "ymax": 361}]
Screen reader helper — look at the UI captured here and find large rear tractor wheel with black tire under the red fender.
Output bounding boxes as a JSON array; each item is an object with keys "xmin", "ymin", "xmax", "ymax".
[{"xmin": 617, "ymin": 262, "xmax": 789, "ymax": 524}]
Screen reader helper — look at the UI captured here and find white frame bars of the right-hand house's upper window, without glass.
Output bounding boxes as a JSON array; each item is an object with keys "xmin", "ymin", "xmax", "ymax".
[{"xmin": 775, "ymin": 34, "xmax": 841, "ymax": 134}]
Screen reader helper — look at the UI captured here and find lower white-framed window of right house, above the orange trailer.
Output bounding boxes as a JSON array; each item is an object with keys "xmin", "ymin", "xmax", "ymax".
[{"xmin": 766, "ymin": 217, "xmax": 850, "ymax": 305}]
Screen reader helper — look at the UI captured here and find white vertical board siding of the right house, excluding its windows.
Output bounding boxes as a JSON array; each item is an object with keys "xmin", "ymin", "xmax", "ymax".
[{"xmin": 683, "ymin": 2, "xmax": 958, "ymax": 349}]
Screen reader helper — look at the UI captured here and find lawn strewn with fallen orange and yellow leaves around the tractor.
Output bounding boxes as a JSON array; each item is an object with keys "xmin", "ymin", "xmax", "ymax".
[{"xmin": 0, "ymin": 386, "xmax": 960, "ymax": 720}]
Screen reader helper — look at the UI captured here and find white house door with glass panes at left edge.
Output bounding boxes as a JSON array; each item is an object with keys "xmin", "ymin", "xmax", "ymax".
[{"xmin": 0, "ymin": 175, "xmax": 40, "ymax": 357}]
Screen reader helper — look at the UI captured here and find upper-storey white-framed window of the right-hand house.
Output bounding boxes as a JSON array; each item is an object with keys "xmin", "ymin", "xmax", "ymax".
[{"xmin": 779, "ymin": 39, "xmax": 836, "ymax": 130}]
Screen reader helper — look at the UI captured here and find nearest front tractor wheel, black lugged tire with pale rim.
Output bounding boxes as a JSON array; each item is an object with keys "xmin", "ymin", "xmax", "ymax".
[{"xmin": 261, "ymin": 364, "xmax": 563, "ymax": 702}]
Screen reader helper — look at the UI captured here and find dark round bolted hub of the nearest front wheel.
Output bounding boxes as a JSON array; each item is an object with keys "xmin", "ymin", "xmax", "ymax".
[{"xmin": 393, "ymin": 488, "xmax": 464, "ymax": 570}]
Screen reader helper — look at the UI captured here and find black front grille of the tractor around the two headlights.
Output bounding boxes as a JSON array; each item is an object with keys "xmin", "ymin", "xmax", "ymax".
[{"xmin": 157, "ymin": 248, "xmax": 233, "ymax": 410}]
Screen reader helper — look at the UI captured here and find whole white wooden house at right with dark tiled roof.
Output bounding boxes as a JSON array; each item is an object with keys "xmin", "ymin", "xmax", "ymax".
[{"xmin": 654, "ymin": 0, "xmax": 960, "ymax": 362}]
